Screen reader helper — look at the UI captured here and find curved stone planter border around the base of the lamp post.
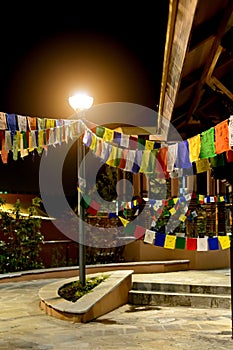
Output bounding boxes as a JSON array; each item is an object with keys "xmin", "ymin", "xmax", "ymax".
[{"xmin": 39, "ymin": 270, "xmax": 133, "ymax": 323}]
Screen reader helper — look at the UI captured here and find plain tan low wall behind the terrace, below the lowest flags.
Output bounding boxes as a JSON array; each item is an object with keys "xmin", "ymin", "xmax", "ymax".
[{"xmin": 124, "ymin": 240, "xmax": 230, "ymax": 270}]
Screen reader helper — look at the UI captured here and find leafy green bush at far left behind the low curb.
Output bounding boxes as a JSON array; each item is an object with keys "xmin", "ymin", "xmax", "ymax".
[{"xmin": 0, "ymin": 198, "xmax": 44, "ymax": 273}]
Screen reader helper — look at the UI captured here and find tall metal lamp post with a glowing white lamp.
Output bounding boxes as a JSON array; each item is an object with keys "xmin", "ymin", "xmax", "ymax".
[{"xmin": 69, "ymin": 93, "xmax": 93, "ymax": 286}]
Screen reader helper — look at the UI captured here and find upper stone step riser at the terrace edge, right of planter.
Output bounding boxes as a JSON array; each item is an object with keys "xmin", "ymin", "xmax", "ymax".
[{"xmin": 132, "ymin": 281, "xmax": 231, "ymax": 295}]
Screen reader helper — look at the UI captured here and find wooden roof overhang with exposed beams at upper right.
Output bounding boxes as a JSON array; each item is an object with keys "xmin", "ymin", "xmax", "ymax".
[{"xmin": 158, "ymin": 0, "xmax": 233, "ymax": 139}]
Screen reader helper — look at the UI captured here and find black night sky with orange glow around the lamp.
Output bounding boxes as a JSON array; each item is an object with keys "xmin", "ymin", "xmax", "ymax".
[{"xmin": 0, "ymin": 0, "xmax": 168, "ymax": 192}]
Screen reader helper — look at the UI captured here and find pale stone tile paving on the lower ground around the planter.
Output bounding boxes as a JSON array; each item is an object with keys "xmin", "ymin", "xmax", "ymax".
[{"xmin": 0, "ymin": 274, "xmax": 233, "ymax": 350}]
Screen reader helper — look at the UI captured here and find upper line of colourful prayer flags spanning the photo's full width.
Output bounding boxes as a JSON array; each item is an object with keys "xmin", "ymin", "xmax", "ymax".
[{"xmin": 0, "ymin": 112, "xmax": 233, "ymax": 178}]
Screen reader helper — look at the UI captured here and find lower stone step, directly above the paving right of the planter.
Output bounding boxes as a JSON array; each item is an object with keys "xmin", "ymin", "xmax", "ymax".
[{"xmin": 128, "ymin": 290, "xmax": 231, "ymax": 309}]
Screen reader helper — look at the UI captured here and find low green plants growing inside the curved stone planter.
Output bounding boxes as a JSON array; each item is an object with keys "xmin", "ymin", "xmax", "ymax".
[{"xmin": 58, "ymin": 275, "xmax": 109, "ymax": 303}]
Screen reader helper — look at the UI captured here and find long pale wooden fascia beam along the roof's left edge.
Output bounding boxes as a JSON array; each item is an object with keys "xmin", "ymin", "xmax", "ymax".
[{"xmin": 158, "ymin": 0, "xmax": 198, "ymax": 137}]
